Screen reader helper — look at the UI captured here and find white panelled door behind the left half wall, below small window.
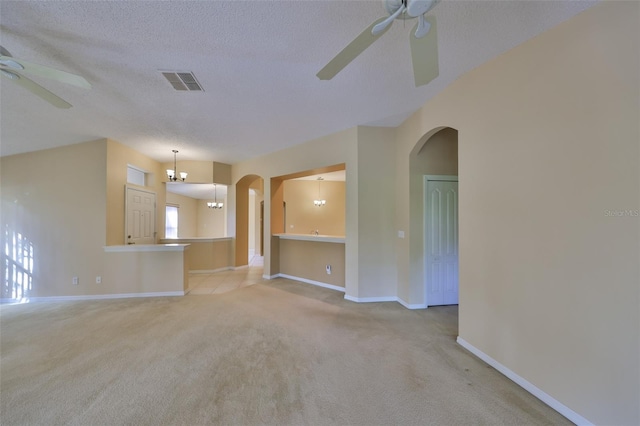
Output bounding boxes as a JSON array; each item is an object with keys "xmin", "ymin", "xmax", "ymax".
[{"xmin": 125, "ymin": 186, "xmax": 156, "ymax": 244}]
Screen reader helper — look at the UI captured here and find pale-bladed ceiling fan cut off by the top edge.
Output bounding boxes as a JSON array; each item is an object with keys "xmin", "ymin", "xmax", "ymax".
[{"xmin": 316, "ymin": 0, "xmax": 440, "ymax": 87}]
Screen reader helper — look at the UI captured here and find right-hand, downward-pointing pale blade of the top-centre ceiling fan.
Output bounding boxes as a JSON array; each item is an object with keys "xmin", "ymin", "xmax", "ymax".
[{"xmin": 409, "ymin": 16, "xmax": 440, "ymax": 87}]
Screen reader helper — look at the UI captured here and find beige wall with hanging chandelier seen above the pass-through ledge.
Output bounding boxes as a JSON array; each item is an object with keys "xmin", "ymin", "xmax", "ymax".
[{"xmin": 284, "ymin": 180, "xmax": 346, "ymax": 236}]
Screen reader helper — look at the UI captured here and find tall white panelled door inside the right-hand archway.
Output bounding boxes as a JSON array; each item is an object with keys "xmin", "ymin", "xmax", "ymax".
[{"xmin": 424, "ymin": 176, "xmax": 458, "ymax": 306}]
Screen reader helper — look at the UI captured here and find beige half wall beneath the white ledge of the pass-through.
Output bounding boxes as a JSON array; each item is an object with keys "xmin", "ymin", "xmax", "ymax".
[{"xmin": 280, "ymin": 239, "xmax": 344, "ymax": 287}]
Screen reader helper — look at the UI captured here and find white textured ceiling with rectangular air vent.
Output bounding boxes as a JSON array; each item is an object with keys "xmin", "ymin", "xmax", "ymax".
[{"xmin": 0, "ymin": 0, "xmax": 594, "ymax": 163}]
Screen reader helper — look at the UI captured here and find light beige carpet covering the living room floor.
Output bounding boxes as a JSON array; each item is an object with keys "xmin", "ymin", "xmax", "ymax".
[{"xmin": 0, "ymin": 279, "xmax": 570, "ymax": 425}]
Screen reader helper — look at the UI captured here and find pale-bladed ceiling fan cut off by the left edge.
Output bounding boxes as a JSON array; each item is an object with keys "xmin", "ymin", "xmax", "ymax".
[{"xmin": 0, "ymin": 46, "xmax": 91, "ymax": 108}]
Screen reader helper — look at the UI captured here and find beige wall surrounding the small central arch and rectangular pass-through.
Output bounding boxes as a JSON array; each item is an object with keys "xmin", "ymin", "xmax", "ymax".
[{"xmin": 228, "ymin": 127, "xmax": 396, "ymax": 301}]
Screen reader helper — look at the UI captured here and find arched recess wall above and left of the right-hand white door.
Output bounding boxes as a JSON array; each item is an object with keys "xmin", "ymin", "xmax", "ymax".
[{"xmin": 409, "ymin": 127, "xmax": 458, "ymax": 308}]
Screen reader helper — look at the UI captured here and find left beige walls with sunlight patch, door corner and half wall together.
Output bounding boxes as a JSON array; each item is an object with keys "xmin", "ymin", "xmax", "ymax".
[{"xmin": 0, "ymin": 139, "xmax": 184, "ymax": 298}]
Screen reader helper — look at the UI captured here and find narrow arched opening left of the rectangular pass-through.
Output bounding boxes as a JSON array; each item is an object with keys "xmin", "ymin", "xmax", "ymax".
[{"xmin": 234, "ymin": 175, "xmax": 264, "ymax": 267}]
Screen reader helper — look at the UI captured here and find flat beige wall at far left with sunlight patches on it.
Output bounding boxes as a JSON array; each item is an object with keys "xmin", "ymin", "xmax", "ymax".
[{"xmin": 0, "ymin": 140, "xmax": 107, "ymax": 298}]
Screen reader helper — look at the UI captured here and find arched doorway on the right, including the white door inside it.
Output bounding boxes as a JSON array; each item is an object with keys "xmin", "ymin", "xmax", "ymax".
[{"xmin": 409, "ymin": 127, "xmax": 458, "ymax": 307}]
